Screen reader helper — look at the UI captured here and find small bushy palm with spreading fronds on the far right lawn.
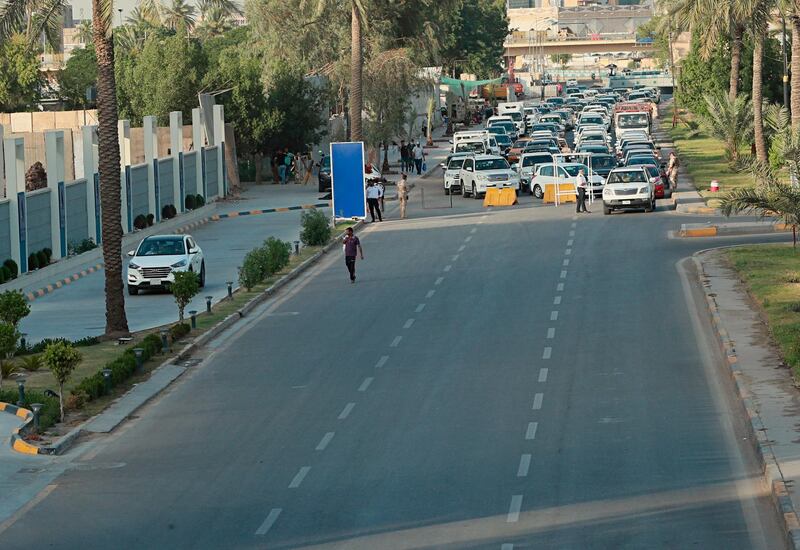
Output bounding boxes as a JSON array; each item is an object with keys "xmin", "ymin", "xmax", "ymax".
[{"xmin": 702, "ymin": 93, "xmax": 753, "ymax": 167}]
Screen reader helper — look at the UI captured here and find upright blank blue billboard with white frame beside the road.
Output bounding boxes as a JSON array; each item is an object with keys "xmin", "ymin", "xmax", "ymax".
[{"xmin": 331, "ymin": 141, "xmax": 367, "ymax": 219}]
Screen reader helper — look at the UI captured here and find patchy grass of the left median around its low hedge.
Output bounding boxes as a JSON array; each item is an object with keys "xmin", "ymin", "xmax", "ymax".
[{"xmin": 4, "ymin": 222, "xmax": 354, "ymax": 424}]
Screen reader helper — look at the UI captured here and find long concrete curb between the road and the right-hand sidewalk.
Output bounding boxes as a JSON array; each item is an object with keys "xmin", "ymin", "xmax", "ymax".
[{"xmin": 692, "ymin": 254, "xmax": 800, "ymax": 550}]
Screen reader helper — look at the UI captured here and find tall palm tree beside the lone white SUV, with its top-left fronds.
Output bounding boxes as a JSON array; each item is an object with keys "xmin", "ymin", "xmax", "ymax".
[{"xmin": 0, "ymin": 0, "xmax": 130, "ymax": 337}]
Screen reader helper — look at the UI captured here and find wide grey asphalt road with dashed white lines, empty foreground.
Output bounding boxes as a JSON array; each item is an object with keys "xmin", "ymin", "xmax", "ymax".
[{"xmin": 0, "ymin": 187, "xmax": 782, "ymax": 550}]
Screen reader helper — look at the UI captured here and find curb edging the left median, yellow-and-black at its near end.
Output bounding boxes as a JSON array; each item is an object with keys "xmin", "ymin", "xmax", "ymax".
[{"xmin": 16, "ymin": 221, "xmax": 365, "ymax": 455}]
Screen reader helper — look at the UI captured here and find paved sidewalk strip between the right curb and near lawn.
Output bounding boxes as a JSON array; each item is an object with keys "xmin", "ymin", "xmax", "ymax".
[{"xmin": 694, "ymin": 250, "xmax": 800, "ymax": 548}]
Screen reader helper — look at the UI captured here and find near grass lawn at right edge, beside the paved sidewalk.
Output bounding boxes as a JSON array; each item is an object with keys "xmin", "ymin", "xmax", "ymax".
[{"xmin": 726, "ymin": 245, "xmax": 800, "ymax": 382}]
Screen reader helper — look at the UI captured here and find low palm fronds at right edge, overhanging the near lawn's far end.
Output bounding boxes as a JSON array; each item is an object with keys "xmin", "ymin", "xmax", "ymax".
[{"xmin": 720, "ymin": 182, "xmax": 800, "ymax": 248}]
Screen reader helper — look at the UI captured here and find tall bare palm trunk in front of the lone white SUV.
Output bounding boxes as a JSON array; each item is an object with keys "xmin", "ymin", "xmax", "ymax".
[{"xmin": 92, "ymin": 7, "xmax": 130, "ymax": 337}]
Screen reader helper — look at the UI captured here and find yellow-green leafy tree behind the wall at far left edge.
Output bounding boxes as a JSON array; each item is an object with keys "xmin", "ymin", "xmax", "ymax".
[{"xmin": 0, "ymin": 35, "xmax": 45, "ymax": 113}]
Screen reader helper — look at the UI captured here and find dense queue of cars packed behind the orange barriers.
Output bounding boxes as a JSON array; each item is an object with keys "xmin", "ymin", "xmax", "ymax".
[{"xmin": 442, "ymin": 82, "xmax": 671, "ymax": 214}]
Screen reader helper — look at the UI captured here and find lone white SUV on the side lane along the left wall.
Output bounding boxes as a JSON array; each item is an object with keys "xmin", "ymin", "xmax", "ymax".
[{"xmin": 128, "ymin": 235, "xmax": 206, "ymax": 296}]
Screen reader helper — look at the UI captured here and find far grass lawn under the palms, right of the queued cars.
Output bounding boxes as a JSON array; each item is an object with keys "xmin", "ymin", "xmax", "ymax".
[{"xmin": 661, "ymin": 105, "xmax": 753, "ymax": 206}]
